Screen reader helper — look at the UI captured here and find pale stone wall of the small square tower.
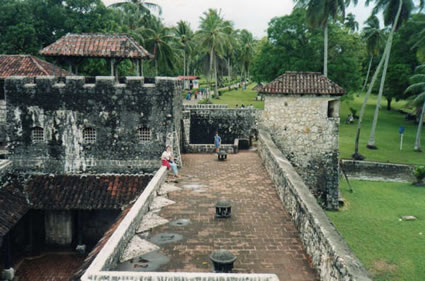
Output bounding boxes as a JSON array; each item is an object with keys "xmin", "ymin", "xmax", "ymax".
[{"xmin": 259, "ymin": 95, "xmax": 339, "ymax": 209}]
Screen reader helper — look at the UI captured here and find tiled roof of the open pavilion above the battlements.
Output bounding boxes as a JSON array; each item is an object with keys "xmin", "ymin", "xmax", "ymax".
[{"xmin": 40, "ymin": 33, "xmax": 153, "ymax": 59}]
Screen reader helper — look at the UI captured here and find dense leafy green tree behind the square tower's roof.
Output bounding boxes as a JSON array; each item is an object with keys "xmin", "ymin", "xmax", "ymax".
[{"xmin": 252, "ymin": 9, "xmax": 365, "ymax": 91}]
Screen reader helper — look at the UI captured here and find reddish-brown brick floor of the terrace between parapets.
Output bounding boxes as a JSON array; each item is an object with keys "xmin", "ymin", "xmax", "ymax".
[{"xmin": 149, "ymin": 151, "xmax": 318, "ymax": 281}]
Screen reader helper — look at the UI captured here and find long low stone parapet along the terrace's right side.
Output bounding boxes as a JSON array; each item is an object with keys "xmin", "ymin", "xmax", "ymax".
[{"xmin": 258, "ymin": 131, "xmax": 372, "ymax": 281}]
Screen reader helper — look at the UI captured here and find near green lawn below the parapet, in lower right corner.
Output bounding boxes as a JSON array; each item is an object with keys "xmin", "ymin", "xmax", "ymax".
[{"xmin": 327, "ymin": 180, "xmax": 425, "ymax": 281}]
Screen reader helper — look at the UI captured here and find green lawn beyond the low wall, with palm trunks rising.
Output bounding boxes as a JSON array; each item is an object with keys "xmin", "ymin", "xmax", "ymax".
[{"xmin": 339, "ymin": 96, "xmax": 425, "ymax": 165}]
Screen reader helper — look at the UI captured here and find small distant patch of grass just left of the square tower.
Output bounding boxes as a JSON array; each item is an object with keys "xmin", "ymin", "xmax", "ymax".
[{"xmin": 212, "ymin": 83, "xmax": 264, "ymax": 109}]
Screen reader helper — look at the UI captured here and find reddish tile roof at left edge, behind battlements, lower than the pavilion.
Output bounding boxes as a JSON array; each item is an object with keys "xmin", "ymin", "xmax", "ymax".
[{"xmin": 0, "ymin": 55, "xmax": 72, "ymax": 78}]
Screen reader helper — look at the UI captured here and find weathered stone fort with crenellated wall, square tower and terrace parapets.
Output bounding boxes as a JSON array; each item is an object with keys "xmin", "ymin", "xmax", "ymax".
[{"xmin": 0, "ymin": 36, "xmax": 370, "ymax": 280}]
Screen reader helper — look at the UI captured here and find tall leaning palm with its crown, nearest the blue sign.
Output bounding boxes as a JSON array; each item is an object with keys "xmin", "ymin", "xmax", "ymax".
[{"xmin": 366, "ymin": 0, "xmax": 414, "ymax": 149}]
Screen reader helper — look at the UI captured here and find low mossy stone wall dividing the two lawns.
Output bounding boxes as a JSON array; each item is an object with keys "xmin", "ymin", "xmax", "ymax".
[{"xmin": 342, "ymin": 160, "xmax": 416, "ymax": 183}]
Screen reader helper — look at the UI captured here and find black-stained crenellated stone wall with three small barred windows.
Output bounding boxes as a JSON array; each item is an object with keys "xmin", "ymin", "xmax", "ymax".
[{"xmin": 5, "ymin": 76, "xmax": 183, "ymax": 173}]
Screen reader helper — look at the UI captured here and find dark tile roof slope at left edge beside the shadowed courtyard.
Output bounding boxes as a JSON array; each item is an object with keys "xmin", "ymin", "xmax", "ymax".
[{"xmin": 0, "ymin": 180, "xmax": 30, "ymax": 242}]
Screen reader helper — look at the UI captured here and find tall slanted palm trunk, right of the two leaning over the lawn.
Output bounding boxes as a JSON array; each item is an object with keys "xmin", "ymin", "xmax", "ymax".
[{"xmin": 367, "ymin": 0, "xmax": 403, "ymax": 149}]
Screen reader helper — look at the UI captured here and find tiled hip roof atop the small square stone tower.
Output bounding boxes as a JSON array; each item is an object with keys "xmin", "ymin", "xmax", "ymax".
[{"xmin": 260, "ymin": 71, "xmax": 345, "ymax": 96}]
